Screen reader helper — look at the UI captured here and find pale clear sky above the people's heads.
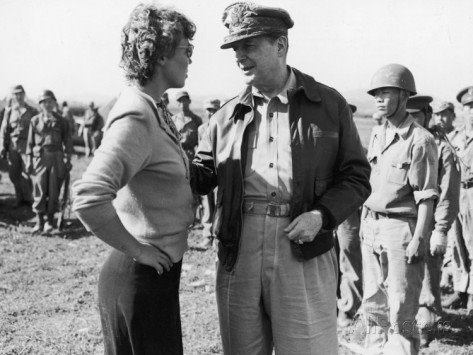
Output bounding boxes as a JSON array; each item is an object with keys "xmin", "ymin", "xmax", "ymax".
[{"xmin": 0, "ymin": 0, "xmax": 473, "ymax": 104}]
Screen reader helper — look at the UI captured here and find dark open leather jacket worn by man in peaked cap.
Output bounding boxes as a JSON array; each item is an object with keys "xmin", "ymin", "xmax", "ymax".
[{"xmin": 191, "ymin": 69, "xmax": 371, "ymax": 271}]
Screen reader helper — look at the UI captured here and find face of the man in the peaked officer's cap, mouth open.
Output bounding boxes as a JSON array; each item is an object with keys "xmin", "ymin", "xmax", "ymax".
[{"xmin": 232, "ymin": 37, "xmax": 281, "ymax": 88}]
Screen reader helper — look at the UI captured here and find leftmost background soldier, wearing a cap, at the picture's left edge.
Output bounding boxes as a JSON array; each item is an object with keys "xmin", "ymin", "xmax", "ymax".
[{"xmin": 0, "ymin": 85, "xmax": 38, "ymax": 205}]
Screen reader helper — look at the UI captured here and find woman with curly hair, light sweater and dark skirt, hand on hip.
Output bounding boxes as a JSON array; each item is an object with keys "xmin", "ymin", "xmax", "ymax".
[{"xmin": 74, "ymin": 4, "xmax": 195, "ymax": 355}]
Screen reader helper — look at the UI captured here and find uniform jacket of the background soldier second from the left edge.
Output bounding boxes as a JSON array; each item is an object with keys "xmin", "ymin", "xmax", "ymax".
[{"xmin": 26, "ymin": 112, "xmax": 72, "ymax": 157}]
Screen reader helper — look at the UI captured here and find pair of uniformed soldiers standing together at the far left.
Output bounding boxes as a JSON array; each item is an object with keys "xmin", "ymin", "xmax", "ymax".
[{"xmin": 0, "ymin": 85, "xmax": 74, "ymax": 233}]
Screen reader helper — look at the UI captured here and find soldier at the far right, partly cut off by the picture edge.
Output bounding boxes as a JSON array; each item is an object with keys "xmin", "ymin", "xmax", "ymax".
[{"xmin": 442, "ymin": 86, "xmax": 473, "ymax": 313}]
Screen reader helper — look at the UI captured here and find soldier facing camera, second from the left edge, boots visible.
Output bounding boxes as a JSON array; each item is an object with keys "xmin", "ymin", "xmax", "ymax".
[{"xmin": 26, "ymin": 90, "xmax": 72, "ymax": 233}]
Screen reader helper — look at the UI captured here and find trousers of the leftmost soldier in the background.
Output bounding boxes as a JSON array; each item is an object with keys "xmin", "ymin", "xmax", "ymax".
[{"xmin": 8, "ymin": 148, "xmax": 33, "ymax": 202}]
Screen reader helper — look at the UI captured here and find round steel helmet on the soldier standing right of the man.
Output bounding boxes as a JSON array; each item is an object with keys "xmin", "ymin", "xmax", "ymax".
[{"xmin": 368, "ymin": 64, "xmax": 417, "ymax": 96}]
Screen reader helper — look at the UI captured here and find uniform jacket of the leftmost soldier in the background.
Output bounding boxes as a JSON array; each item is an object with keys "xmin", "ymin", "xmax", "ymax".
[{"xmin": 0, "ymin": 104, "xmax": 38, "ymax": 154}]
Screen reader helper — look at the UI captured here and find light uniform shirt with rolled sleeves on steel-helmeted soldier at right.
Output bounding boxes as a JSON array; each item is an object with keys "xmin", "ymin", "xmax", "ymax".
[{"xmin": 365, "ymin": 116, "xmax": 438, "ymax": 217}]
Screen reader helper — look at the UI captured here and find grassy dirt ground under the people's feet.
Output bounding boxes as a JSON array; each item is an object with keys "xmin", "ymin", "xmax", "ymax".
[{"xmin": 0, "ymin": 148, "xmax": 473, "ymax": 355}]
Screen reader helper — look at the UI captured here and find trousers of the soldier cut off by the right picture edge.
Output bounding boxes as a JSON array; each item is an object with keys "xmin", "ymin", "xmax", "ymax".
[{"xmin": 451, "ymin": 188, "xmax": 473, "ymax": 295}]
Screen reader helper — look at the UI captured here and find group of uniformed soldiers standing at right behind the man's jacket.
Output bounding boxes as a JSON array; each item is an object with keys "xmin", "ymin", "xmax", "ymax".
[{"xmin": 336, "ymin": 64, "xmax": 473, "ymax": 353}]
